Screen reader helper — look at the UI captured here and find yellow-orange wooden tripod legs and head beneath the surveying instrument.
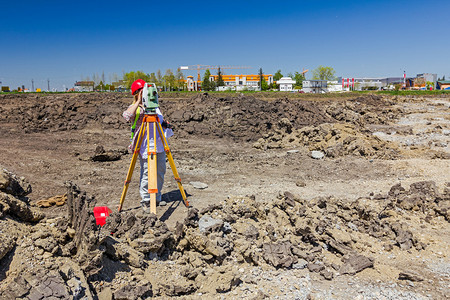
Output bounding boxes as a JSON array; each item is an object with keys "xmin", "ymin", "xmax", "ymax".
[{"xmin": 119, "ymin": 114, "xmax": 189, "ymax": 214}]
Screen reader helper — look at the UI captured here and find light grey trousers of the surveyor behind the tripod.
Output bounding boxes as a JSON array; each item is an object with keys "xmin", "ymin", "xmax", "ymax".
[{"xmin": 139, "ymin": 152, "xmax": 166, "ymax": 202}]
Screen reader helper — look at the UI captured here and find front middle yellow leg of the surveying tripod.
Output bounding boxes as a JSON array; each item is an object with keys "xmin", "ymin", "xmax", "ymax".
[{"xmin": 147, "ymin": 122, "xmax": 159, "ymax": 214}]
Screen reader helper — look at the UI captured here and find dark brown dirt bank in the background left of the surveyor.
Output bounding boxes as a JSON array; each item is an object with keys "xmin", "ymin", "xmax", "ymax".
[{"xmin": 0, "ymin": 93, "xmax": 127, "ymax": 133}]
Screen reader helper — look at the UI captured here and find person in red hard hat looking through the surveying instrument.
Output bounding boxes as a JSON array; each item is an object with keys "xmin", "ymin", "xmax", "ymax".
[{"xmin": 122, "ymin": 79, "xmax": 173, "ymax": 213}]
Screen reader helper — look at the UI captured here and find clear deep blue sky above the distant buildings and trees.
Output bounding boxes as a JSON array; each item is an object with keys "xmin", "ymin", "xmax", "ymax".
[{"xmin": 0, "ymin": 0, "xmax": 450, "ymax": 90}]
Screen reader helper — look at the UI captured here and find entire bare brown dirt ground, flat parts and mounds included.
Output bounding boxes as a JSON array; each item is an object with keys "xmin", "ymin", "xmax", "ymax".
[{"xmin": 0, "ymin": 93, "xmax": 450, "ymax": 299}]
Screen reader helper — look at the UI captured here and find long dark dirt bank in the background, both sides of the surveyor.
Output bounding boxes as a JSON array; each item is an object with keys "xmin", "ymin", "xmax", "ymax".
[{"xmin": 0, "ymin": 93, "xmax": 395, "ymax": 141}]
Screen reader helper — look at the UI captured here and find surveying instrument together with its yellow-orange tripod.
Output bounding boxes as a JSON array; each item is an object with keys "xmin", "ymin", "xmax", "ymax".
[{"xmin": 119, "ymin": 83, "xmax": 189, "ymax": 214}]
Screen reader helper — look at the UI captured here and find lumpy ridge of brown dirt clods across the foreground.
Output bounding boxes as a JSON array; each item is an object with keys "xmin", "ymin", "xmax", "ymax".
[{"xmin": 0, "ymin": 166, "xmax": 450, "ymax": 299}]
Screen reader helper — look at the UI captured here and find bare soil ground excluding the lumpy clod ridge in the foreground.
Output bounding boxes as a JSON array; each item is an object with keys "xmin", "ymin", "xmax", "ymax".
[{"xmin": 0, "ymin": 94, "xmax": 450, "ymax": 299}]
